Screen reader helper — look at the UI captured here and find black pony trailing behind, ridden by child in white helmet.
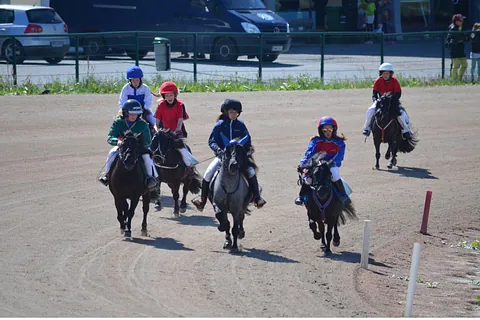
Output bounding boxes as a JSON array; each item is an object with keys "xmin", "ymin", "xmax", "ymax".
[{"xmin": 371, "ymin": 92, "xmax": 418, "ymax": 169}]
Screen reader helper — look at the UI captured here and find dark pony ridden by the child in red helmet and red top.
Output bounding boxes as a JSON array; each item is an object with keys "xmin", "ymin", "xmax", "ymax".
[{"xmin": 151, "ymin": 129, "xmax": 202, "ymax": 217}]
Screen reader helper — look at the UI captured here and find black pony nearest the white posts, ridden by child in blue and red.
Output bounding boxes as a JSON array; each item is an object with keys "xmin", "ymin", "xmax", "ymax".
[{"xmin": 300, "ymin": 153, "xmax": 357, "ymax": 255}]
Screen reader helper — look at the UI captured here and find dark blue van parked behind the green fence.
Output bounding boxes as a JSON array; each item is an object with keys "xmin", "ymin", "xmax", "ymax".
[{"xmin": 50, "ymin": 0, "xmax": 291, "ymax": 62}]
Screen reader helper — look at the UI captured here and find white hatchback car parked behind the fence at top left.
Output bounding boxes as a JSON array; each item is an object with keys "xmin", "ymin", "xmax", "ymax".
[{"xmin": 0, "ymin": 5, "xmax": 70, "ymax": 64}]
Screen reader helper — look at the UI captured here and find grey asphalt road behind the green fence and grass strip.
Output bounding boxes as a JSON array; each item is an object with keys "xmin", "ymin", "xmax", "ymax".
[{"xmin": 0, "ymin": 40, "xmax": 462, "ymax": 84}]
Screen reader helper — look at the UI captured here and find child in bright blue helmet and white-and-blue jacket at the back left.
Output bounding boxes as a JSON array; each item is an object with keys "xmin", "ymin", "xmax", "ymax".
[{"xmin": 118, "ymin": 66, "xmax": 156, "ymax": 127}]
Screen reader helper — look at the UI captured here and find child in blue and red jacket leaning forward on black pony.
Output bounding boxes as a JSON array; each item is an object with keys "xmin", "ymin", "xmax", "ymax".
[{"xmin": 295, "ymin": 116, "xmax": 350, "ymax": 206}]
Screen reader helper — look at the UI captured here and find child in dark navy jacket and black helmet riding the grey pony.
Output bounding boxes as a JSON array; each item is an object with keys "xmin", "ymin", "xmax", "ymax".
[{"xmin": 192, "ymin": 99, "xmax": 266, "ymax": 212}]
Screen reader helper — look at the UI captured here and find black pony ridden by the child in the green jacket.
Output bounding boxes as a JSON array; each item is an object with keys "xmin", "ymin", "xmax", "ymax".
[{"xmin": 108, "ymin": 131, "xmax": 150, "ymax": 237}]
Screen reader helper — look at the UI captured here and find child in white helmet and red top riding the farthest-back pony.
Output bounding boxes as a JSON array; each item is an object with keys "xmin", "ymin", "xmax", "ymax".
[{"xmin": 363, "ymin": 63, "xmax": 411, "ymax": 139}]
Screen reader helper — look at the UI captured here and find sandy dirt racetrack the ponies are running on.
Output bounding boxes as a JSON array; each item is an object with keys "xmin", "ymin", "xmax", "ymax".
[{"xmin": 0, "ymin": 86, "xmax": 480, "ymax": 317}]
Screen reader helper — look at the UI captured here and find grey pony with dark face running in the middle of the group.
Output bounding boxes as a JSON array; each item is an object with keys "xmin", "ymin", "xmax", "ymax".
[{"xmin": 209, "ymin": 134, "xmax": 257, "ymax": 253}]
